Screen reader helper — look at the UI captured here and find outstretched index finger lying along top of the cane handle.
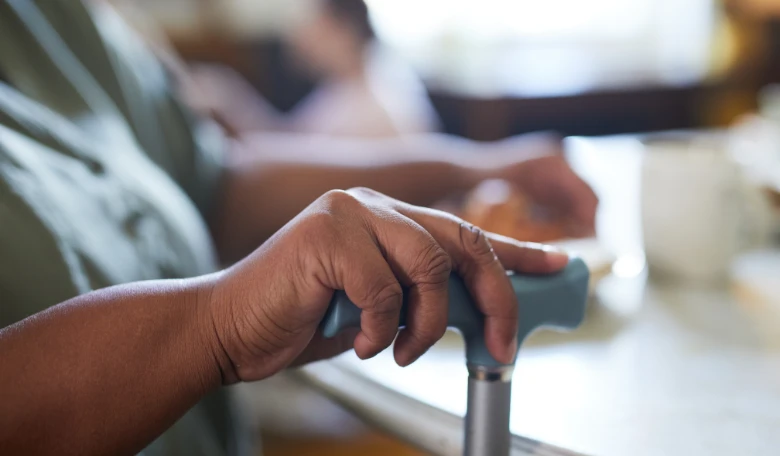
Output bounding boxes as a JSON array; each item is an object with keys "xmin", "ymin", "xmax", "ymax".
[{"xmin": 487, "ymin": 233, "xmax": 569, "ymax": 274}]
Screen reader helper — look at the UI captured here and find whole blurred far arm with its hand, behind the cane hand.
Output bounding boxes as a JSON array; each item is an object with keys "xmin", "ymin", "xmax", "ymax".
[{"xmin": 212, "ymin": 130, "xmax": 598, "ymax": 260}]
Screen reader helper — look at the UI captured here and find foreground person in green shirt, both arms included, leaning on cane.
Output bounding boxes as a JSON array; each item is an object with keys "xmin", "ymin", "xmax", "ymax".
[{"xmin": 0, "ymin": 0, "xmax": 597, "ymax": 456}]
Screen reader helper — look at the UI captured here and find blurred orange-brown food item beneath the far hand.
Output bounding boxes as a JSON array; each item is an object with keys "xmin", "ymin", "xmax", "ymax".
[{"xmin": 459, "ymin": 180, "xmax": 566, "ymax": 242}]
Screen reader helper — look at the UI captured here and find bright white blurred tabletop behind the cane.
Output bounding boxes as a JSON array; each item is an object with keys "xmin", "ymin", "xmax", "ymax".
[{"xmin": 301, "ymin": 137, "xmax": 780, "ymax": 456}]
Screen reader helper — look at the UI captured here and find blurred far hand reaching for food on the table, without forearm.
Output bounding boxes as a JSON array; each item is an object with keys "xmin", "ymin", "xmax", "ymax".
[{"xmin": 488, "ymin": 134, "xmax": 598, "ymax": 237}]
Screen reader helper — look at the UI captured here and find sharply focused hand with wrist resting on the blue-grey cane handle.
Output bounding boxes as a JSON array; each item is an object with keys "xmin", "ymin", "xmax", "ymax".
[{"xmin": 204, "ymin": 189, "xmax": 568, "ymax": 383}]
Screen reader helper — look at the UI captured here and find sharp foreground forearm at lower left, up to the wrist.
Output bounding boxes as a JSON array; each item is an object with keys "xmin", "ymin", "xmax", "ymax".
[{"xmin": 0, "ymin": 281, "xmax": 221, "ymax": 455}]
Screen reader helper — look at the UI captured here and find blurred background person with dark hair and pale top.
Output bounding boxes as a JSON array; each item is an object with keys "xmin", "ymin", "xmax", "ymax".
[{"xmin": 187, "ymin": 0, "xmax": 438, "ymax": 138}]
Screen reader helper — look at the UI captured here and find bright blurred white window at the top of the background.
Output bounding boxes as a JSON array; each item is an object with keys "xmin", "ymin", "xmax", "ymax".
[{"xmin": 367, "ymin": 0, "xmax": 718, "ymax": 96}]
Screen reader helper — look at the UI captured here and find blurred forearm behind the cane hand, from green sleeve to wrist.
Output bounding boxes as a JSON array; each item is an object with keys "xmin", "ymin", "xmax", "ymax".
[{"xmin": 215, "ymin": 135, "xmax": 488, "ymax": 260}]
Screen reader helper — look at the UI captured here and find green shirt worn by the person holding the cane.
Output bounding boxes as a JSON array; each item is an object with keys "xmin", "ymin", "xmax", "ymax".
[{"xmin": 0, "ymin": 0, "xmax": 247, "ymax": 456}]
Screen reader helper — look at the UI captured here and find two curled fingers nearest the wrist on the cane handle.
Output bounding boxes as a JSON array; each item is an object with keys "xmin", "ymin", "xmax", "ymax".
[{"xmin": 320, "ymin": 189, "xmax": 451, "ymax": 366}]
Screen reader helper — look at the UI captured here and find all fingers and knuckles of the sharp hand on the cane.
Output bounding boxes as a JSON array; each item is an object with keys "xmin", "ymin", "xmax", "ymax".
[{"xmin": 316, "ymin": 189, "xmax": 569, "ymax": 366}]
